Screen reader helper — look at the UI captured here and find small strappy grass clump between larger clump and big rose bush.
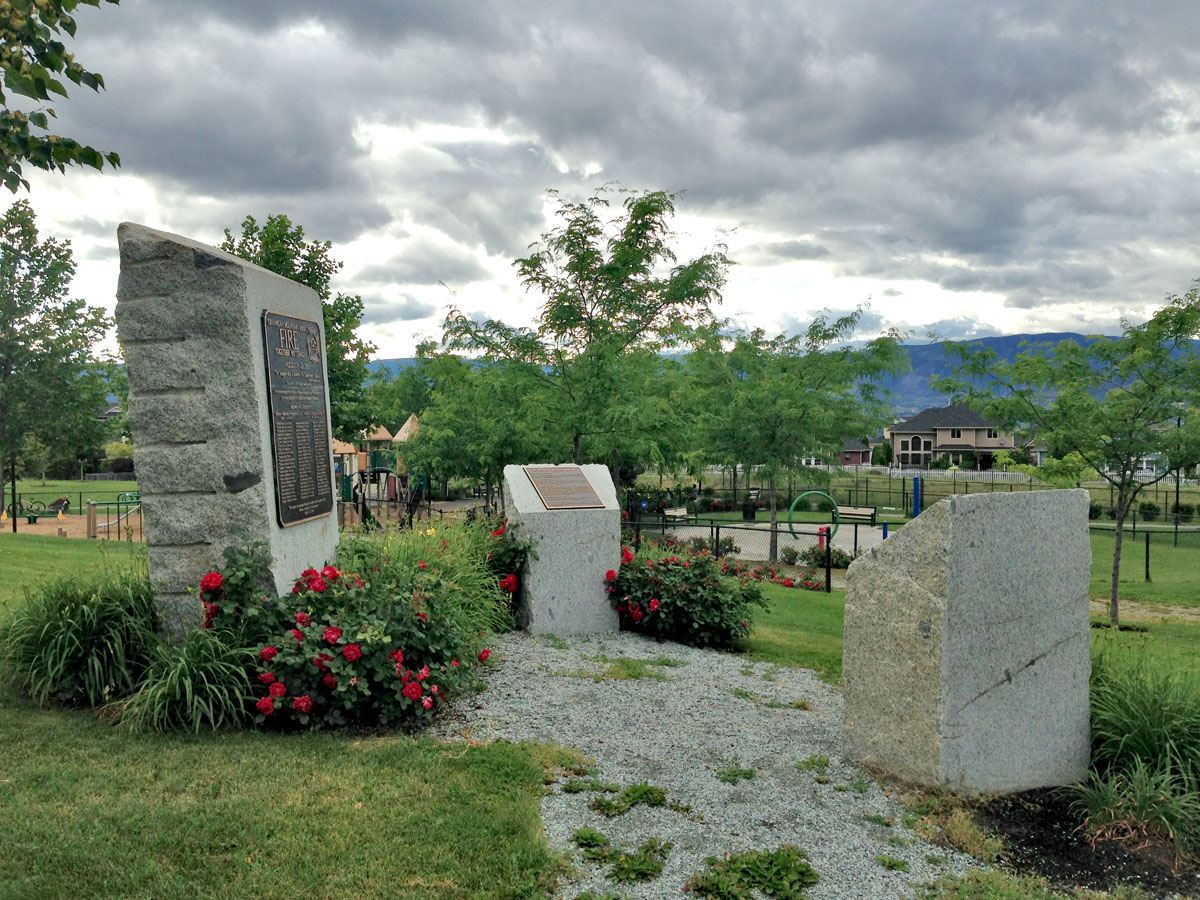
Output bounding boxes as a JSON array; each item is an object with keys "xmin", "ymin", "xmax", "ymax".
[{"xmin": 120, "ymin": 629, "xmax": 254, "ymax": 732}]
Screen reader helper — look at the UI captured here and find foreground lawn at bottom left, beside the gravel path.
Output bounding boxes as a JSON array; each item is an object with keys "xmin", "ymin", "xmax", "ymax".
[{"xmin": 0, "ymin": 702, "xmax": 565, "ymax": 900}]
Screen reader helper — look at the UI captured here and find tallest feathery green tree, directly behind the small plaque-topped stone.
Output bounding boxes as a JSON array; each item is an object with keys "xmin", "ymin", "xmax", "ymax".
[{"xmin": 443, "ymin": 191, "xmax": 728, "ymax": 480}]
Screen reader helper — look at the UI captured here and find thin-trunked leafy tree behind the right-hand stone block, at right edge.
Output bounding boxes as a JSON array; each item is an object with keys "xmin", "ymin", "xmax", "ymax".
[{"xmin": 940, "ymin": 296, "xmax": 1200, "ymax": 626}]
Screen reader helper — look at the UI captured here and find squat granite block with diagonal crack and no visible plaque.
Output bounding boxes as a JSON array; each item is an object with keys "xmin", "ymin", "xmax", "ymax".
[{"xmin": 842, "ymin": 491, "xmax": 1092, "ymax": 793}]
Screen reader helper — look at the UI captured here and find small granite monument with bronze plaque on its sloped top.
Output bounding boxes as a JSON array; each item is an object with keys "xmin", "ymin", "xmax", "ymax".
[{"xmin": 504, "ymin": 466, "xmax": 620, "ymax": 635}]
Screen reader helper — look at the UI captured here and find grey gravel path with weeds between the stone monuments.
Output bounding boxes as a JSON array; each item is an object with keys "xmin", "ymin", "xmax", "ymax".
[{"xmin": 439, "ymin": 632, "xmax": 971, "ymax": 900}]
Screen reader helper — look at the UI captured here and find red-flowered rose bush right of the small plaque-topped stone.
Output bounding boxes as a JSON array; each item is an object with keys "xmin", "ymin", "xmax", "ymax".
[{"xmin": 606, "ymin": 547, "xmax": 767, "ymax": 647}]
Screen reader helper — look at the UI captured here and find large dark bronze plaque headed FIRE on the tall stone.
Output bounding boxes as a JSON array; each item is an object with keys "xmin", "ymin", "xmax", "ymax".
[{"xmin": 263, "ymin": 310, "xmax": 334, "ymax": 528}]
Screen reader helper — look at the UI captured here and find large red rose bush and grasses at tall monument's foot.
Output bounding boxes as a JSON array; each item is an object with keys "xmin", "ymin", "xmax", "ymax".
[{"xmin": 202, "ymin": 523, "xmax": 511, "ymax": 726}]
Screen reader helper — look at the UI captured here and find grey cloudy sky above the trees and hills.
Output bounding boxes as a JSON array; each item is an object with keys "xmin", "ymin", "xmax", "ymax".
[{"xmin": 16, "ymin": 0, "xmax": 1200, "ymax": 356}]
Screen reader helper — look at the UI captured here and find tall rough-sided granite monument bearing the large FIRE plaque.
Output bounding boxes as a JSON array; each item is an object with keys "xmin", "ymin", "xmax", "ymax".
[{"xmin": 116, "ymin": 222, "xmax": 337, "ymax": 635}]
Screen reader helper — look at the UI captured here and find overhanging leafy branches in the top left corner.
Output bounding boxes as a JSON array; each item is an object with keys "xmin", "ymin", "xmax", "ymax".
[{"xmin": 0, "ymin": 0, "xmax": 121, "ymax": 193}]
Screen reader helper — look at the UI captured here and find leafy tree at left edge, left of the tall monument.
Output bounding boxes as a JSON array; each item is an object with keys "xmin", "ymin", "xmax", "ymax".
[{"xmin": 0, "ymin": 200, "xmax": 109, "ymax": 520}]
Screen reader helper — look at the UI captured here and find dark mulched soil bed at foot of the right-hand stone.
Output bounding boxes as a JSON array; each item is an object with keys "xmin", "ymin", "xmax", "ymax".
[{"xmin": 978, "ymin": 790, "xmax": 1200, "ymax": 896}]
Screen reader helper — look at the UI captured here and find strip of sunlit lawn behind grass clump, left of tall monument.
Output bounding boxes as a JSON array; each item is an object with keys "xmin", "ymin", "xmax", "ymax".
[{"xmin": 0, "ymin": 532, "xmax": 145, "ymax": 610}]
